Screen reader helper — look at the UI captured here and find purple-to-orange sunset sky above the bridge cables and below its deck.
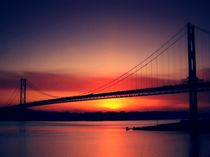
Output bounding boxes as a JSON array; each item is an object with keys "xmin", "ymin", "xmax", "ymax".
[{"xmin": 0, "ymin": 0, "xmax": 210, "ymax": 112}]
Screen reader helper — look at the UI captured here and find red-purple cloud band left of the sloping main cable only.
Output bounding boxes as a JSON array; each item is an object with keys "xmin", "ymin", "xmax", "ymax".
[{"xmin": 0, "ymin": 71, "xmax": 119, "ymax": 92}]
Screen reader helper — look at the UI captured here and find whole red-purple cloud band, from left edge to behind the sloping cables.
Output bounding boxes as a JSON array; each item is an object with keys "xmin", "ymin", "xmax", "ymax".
[{"xmin": 0, "ymin": 71, "xmax": 197, "ymax": 93}]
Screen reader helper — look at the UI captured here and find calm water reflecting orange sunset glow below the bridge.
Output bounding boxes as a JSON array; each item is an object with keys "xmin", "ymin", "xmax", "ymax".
[{"xmin": 0, "ymin": 121, "xmax": 210, "ymax": 157}]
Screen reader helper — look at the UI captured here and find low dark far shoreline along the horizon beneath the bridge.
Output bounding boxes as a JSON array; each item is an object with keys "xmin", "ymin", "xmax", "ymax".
[{"xmin": 0, "ymin": 106, "xmax": 210, "ymax": 121}]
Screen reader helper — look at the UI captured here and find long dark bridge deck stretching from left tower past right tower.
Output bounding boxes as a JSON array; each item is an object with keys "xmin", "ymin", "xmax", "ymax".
[{"xmin": 25, "ymin": 82, "xmax": 210, "ymax": 107}]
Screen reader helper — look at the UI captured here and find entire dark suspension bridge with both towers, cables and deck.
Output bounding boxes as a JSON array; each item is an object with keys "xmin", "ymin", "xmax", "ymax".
[{"xmin": 4, "ymin": 23, "xmax": 210, "ymax": 125}]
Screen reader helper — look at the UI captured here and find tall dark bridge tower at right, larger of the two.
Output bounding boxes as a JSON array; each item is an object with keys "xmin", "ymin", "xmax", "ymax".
[{"xmin": 187, "ymin": 23, "xmax": 198, "ymax": 128}]
